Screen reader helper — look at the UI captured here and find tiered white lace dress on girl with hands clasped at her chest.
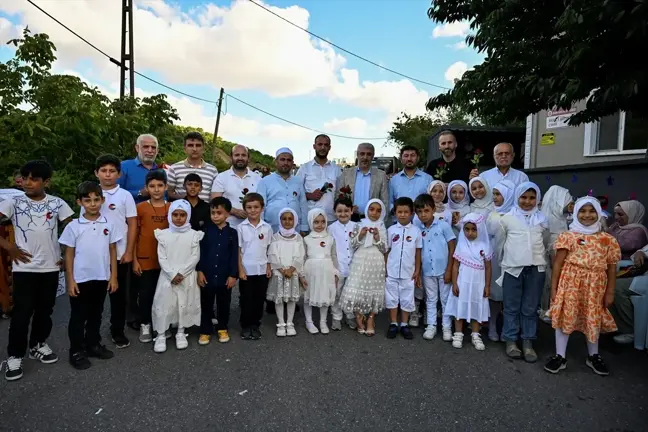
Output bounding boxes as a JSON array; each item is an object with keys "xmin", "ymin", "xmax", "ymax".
[{"xmin": 340, "ymin": 225, "xmax": 387, "ymax": 315}]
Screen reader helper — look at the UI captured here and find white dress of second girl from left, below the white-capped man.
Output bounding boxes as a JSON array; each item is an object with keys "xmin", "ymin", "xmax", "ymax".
[{"xmin": 266, "ymin": 233, "xmax": 304, "ymax": 303}]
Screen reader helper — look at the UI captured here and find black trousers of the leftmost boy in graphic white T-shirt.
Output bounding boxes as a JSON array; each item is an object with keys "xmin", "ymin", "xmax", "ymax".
[{"xmin": 7, "ymin": 271, "xmax": 59, "ymax": 357}]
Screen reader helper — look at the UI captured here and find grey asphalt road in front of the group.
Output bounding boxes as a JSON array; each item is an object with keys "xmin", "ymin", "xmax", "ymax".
[{"xmin": 0, "ymin": 295, "xmax": 648, "ymax": 432}]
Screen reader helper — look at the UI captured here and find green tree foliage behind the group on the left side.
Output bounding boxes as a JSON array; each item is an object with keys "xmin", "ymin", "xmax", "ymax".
[{"xmin": 0, "ymin": 29, "xmax": 273, "ymax": 202}]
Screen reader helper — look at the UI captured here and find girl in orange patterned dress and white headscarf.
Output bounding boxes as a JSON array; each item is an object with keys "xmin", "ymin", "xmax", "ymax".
[{"xmin": 545, "ymin": 196, "xmax": 621, "ymax": 375}]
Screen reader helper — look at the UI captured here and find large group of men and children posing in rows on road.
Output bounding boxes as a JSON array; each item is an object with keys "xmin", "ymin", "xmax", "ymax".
[{"xmin": 0, "ymin": 132, "xmax": 645, "ymax": 380}]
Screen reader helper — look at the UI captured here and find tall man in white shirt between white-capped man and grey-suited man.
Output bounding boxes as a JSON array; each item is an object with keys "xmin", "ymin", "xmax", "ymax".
[{"xmin": 297, "ymin": 134, "xmax": 341, "ymax": 225}]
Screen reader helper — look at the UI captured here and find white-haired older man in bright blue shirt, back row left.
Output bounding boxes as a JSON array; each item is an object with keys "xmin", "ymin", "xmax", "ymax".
[{"xmin": 117, "ymin": 134, "xmax": 163, "ymax": 203}]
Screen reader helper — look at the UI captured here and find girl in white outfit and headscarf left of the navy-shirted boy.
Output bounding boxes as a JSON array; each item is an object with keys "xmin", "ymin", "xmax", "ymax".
[{"xmin": 151, "ymin": 200, "xmax": 205, "ymax": 353}]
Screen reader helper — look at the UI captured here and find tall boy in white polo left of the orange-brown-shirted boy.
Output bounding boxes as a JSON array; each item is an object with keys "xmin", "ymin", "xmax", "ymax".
[{"xmin": 92, "ymin": 154, "xmax": 138, "ymax": 348}]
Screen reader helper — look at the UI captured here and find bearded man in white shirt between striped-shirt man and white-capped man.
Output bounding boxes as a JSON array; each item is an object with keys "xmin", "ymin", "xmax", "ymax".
[{"xmin": 211, "ymin": 144, "xmax": 261, "ymax": 228}]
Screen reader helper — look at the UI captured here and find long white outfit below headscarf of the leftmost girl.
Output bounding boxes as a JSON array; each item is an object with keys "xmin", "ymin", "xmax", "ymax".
[{"xmin": 151, "ymin": 229, "xmax": 205, "ymax": 333}]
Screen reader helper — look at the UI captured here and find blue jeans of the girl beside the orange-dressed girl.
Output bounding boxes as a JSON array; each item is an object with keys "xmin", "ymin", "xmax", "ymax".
[{"xmin": 502, "ymin": 266, "xmax": 545, "ymax": 342}]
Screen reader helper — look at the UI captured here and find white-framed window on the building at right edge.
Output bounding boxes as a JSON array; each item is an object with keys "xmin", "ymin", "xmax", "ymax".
[{"xmin": 584, "ymin": 112, "xmax": 648, "ymax": 156}]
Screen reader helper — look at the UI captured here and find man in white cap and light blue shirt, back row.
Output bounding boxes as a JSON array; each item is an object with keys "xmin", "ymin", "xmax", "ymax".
[{"xmin": 257, "ymin": 147, "xmax": 308, "ymax": 233}]
